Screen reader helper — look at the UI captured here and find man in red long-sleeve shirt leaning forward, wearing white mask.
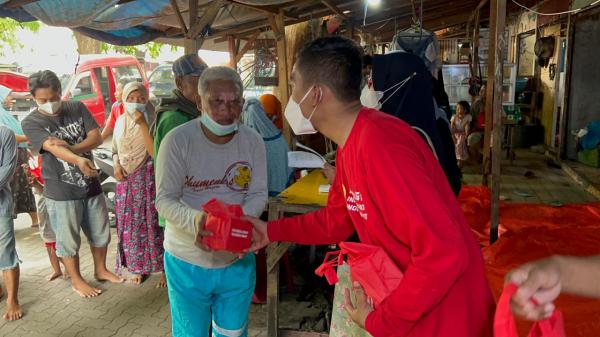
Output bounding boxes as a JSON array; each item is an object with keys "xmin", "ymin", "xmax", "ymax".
[{"xmin": 250, "ymin": 37, "xmax": 495, "ymax": 337}]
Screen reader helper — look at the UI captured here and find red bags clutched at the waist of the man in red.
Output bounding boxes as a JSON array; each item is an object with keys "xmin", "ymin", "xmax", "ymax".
[{"xmin": 315, "ymin": 242, "xmax": 404, "ymax": 306}]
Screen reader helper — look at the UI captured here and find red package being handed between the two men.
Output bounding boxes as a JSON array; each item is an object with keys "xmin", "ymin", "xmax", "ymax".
[{"xmin": 202, "ymin": 199, "xmax": 252, "ymax": 253}]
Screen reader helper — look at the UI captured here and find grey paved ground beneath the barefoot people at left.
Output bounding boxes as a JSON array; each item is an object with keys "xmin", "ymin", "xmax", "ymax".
[{"xmin": 0, "ymin": 215, "xmax": 267, "ymax": 337}]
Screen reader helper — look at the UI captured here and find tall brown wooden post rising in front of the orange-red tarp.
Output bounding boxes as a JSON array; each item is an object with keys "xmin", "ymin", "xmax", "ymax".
[{"xmin": 485, "ymin": 0, "xmax": 507, "ymax": 243}]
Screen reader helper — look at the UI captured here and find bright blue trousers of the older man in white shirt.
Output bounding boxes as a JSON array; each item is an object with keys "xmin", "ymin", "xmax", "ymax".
[{"xmin": 165, "ymin": 252, "xmax": 256, "ymax": 337}]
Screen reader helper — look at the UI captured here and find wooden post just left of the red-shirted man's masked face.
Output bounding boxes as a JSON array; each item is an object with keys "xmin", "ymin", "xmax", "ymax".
[{"xmin": 269, "ymin": 10, "xmax": 292, "ymax": 146}]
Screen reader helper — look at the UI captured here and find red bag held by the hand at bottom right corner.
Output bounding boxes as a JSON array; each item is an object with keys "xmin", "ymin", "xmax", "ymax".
[{"xmin": 494, "ymin": 283, "xmax": 566, "ymax": 337}]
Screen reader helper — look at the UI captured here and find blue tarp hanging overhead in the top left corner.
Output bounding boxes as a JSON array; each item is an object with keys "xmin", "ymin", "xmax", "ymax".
[{"xmin": 0, "ymin": 0, "xmax": 183, "ymax": 45}]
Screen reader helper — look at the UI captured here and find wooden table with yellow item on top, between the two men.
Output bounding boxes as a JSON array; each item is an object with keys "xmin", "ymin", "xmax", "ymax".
[{"xmin": 267, "ymin": 170, "xmax": 328, "ymax": 337}]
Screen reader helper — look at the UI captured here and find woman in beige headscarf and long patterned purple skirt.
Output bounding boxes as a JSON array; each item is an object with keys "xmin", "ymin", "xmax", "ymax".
[{"xmin": 112, "ymin": 82, "xmax": 166, "ymax": 287}]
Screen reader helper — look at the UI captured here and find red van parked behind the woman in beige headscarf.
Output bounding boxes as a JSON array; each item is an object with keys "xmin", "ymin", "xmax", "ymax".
[{"xmin": 63, "ymin": 55, "xmax": 149, "ymax": 127}]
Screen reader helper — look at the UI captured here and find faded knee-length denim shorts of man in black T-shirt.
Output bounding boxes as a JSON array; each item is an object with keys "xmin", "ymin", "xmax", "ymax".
[{"xmin": 46, "ymin": 194, "xmax": 110, "ymax": 257}]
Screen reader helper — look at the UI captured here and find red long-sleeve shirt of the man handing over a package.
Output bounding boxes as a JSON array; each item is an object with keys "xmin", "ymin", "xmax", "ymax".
[{"xmin": 268, "ymin": 108, "xmax": 495, "ymax": 337}]
